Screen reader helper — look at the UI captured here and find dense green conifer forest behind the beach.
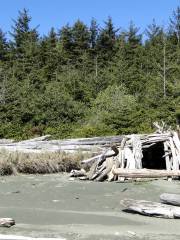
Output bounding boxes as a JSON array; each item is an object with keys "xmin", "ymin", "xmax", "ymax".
[{"xmin": 0, "ymin": 7, "xmax": 180, "ymax": 139}]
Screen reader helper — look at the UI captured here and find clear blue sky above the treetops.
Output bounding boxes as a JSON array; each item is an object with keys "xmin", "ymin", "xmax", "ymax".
[{"xmin": 0, "ymin": 0, "xmax": 180, "ymax": 35}]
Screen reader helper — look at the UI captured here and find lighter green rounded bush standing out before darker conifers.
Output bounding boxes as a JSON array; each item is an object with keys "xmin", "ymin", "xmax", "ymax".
[{"xmin": 84, "ymin": 85, "xmax": 137, "ymax": 134}]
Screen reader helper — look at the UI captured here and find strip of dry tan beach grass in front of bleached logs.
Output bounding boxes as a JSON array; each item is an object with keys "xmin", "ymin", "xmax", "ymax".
[{"xmin": 0, "ymin": 150, "xmax": 91, "ymax": 176}]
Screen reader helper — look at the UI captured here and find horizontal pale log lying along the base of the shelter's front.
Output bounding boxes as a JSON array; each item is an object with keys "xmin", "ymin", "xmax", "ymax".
[{"xmin": 113, "ymin": 168, "xmax": 180, "ymax": 178}]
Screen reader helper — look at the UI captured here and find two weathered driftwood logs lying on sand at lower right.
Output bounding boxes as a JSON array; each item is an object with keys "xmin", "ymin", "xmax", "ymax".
[{"xmin": 121, "ymin": 193, "xmax": 180, "ymax": 218}]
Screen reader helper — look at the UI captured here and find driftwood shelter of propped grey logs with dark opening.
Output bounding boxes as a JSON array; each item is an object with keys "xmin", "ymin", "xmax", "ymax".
[{"xmin": 71, "ymin": 123, "xmax": 180, "ymax": 181}]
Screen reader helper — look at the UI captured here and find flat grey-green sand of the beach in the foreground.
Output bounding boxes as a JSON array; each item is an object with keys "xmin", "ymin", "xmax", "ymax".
[{"xmin": 0, "ymin": 174, "xmax": 180, "ymax": 240}]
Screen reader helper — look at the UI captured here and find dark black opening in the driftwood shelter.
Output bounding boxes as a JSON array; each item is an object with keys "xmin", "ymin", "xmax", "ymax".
[{"xmin": 142, "ymin": 142, "xmax": 166, "ymax": 169}]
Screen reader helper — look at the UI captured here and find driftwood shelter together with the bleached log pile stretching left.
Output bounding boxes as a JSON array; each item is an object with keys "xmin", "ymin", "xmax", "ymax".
[{"xmin": 0, "ymin": 123, "xmax": 180, "ymax": 181}]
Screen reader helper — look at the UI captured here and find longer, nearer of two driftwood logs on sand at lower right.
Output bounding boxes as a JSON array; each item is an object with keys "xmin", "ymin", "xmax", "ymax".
[{"xmin": 121, "ymin": 199, "xmax": 180, "ymax": 218}]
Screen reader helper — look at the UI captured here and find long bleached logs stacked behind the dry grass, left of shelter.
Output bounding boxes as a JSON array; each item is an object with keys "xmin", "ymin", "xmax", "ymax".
[{"xmin": 0, "ymin": 135, "xmax": 123, "ymax": 154}]
